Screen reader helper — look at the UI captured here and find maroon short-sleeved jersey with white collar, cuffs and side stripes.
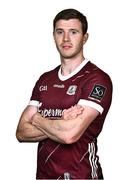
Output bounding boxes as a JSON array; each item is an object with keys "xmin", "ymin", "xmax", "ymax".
[{"xmin": 29, "ymin": 60, "xmax": 112, "ymax": 179}]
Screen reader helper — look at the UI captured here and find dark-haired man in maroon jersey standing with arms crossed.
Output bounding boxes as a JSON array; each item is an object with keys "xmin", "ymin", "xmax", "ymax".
[{"xmin": 16, "ymin": 9, "xmax": 112, "ymax": 179}]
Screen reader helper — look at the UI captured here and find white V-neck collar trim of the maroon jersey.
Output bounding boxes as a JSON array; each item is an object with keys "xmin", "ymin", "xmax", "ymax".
[{"xmin": 58, "ymin": 59, "xmax": 89, "ymax": 81}]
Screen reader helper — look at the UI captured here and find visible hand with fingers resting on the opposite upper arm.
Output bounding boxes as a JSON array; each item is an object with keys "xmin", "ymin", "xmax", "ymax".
[{"xmin": 62, "ymin": 105, "xmax": 84, "ymax": 120}]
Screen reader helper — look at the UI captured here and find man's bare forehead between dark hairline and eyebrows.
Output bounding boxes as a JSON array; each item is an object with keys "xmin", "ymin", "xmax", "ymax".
[{"xmin": 55, "ymin": 19, "xmax": 82, "ymax": 29}]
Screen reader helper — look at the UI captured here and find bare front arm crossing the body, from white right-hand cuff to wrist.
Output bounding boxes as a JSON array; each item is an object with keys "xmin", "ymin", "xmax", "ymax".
[{"xmin": 32, "ymin": 106, "xmax": 99, "ymax": 144}]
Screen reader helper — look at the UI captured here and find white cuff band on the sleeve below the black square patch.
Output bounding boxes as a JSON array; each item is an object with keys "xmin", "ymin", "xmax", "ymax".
[{"xmin": 78, "ymin": 99, "xmax": 104, "ymax": 114}]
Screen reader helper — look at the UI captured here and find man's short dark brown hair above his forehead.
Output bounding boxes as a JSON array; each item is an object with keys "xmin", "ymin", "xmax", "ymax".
[{"xmin": 53, "ymin": 9, "xmax": 88, "ymax": 34}]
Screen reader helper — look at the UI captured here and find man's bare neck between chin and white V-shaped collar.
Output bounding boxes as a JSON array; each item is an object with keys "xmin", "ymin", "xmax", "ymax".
[{"xmin": 61, "ymin": 56, "xmax": 85, "ymax": 76}]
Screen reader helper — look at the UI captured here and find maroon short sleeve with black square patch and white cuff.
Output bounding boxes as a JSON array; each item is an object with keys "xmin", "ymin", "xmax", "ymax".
[{"xmin": 78, "ymin": 71, "xmax": 112, "ymax": 114}]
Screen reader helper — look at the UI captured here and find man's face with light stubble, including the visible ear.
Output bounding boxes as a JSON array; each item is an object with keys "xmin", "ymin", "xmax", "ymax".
[{"xmin": 54, "ymin": 19, "xmax": 88, "ymax": 59}]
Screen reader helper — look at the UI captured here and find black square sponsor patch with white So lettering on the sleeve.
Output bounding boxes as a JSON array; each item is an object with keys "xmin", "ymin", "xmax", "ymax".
[{"xmin": 89, "ymin": 84, "xmax": 106, "ymax": 101}]
